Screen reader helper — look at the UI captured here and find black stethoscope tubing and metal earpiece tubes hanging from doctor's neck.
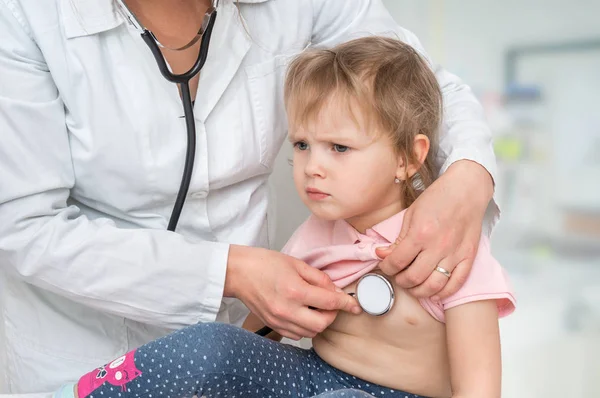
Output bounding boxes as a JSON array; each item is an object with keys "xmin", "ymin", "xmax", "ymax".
[{"xmin": 116, "ymin": 0, "xmax": 219, "ymax": 231}]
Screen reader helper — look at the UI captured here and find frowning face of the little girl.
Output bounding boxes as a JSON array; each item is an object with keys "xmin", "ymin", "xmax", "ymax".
[{"xmin": 289, "ymin": 99, "xmax": 402, "ymax": 232}]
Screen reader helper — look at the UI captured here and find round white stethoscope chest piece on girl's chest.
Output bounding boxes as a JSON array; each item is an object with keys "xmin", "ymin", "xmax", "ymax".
[{"xmin": 356, "ymin": 273, "xmax": 394, "ymax": 315}]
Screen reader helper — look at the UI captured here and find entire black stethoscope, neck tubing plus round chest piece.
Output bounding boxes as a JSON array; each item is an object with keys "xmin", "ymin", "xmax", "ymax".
[{"xmin": 116, "ymin": 0, "xmax": 394, "ymax": 336}]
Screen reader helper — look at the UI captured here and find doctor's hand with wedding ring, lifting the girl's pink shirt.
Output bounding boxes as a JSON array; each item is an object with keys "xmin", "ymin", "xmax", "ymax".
[{"xmin": 377, "ymin": 160, "xmax": 494, "ymax": 301}]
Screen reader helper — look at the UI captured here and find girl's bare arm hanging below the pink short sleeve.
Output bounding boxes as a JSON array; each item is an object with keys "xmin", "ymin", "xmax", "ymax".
[{"xmin": 445, "ymin": 300, "xmax": 502, "ymax": 398}]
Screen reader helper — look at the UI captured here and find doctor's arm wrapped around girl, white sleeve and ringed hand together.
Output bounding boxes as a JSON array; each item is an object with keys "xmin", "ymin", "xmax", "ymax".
[{"xmin": 311, "ymin": 0, "xmax": 499, "ymax": 299}]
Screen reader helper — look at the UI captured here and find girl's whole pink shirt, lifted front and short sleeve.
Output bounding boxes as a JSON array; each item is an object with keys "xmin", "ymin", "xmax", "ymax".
[{"xmin": 282, "ymin": 211, "xmax": 516, "ymax": 322}]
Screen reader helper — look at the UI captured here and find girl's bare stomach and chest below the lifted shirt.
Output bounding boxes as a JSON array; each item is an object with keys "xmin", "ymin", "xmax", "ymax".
[{"xmin": 313, "ymin": 276, "xmax": 452, "ymax": 398}]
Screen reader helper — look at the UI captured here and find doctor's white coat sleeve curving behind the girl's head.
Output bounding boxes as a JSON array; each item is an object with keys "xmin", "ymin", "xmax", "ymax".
[{"xmin": 311, "ymin": 0, "xmax": 500, "ymax": 236}]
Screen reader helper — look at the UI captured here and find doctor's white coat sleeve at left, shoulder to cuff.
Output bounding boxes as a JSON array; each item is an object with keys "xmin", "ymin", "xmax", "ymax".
[{"xmin": 0, "ymin": 1, "xmax": 229, "ymax": 328}]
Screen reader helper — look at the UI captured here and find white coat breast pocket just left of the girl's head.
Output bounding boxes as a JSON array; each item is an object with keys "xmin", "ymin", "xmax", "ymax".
[{"xmin": 245, "ymin": 55, "xmax": 291, "ymax": 168}]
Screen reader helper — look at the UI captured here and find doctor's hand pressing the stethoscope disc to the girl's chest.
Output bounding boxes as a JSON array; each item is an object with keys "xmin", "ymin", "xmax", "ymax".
[{"xmin": 223, "ymin": 245, "xmax": 361, "ymax": 340}]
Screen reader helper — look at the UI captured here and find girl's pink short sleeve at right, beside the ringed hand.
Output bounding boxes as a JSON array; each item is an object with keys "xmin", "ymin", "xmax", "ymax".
[{"xmin": 420, "ymin": 235, "xmax": 516, "ymax": 322}]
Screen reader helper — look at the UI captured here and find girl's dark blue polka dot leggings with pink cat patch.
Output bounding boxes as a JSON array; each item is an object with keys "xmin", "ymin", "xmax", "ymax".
[{"xmin": 77, "ymin": 323, "xmax": 422, "ymax": 398}]
